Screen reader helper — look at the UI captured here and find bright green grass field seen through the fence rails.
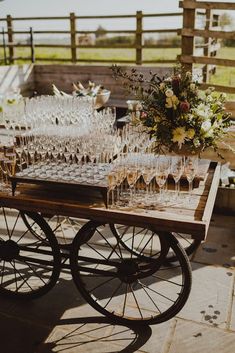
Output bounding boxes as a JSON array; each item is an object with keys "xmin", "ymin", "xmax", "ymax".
[{"xmin": 0, "ymin": 47, "xmax": 235, "ymax": 99}]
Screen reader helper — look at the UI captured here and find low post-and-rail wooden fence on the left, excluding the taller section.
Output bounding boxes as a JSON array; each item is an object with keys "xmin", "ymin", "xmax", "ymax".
[{"xmin": 0, "ymin": 11, "xmax": 182, "ymax": 65}]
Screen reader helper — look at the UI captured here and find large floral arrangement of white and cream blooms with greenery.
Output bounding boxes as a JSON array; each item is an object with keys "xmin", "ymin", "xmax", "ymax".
[{"xmin": 112, "ymin": 66, "xmax": 231, "ymax": 153}]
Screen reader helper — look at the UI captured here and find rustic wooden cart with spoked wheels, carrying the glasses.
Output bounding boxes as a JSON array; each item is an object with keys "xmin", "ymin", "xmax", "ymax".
[{"xmin": 0, "ymin": 163, "xmax": 220, "ymax": 324}]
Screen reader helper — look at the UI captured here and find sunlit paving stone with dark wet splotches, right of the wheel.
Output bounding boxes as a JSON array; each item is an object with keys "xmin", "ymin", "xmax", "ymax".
[{"xmin": 178, "ymin": 263, "xmax": 233, "ymax": 328}]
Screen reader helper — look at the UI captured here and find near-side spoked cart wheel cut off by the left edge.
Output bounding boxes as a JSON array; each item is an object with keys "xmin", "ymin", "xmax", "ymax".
[{"xmin": 0, "ymin": 208, "xmax": 61, "ymax": 299}]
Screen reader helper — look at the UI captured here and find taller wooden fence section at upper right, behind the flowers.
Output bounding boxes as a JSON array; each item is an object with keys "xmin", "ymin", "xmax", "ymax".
[{"xmin": 178, "ymin": 0, "xmax": 235, "ymax": 94}]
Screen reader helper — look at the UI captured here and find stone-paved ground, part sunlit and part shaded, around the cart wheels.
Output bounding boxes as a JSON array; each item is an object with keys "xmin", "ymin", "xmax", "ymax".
[{"xmin": 0, "ymin": 215, "xmax": 235, "ymax": 353}]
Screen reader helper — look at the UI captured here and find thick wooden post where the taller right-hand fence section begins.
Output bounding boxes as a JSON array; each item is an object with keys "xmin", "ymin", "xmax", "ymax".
[{"xmin": 181, "ymin": 0, "xmax": 196, "ymax": 72}]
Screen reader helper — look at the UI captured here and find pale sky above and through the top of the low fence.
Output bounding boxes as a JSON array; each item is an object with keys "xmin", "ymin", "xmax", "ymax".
[{"xmin": 0, "ymin": 0, "xmax": 234, "ymax": 30}]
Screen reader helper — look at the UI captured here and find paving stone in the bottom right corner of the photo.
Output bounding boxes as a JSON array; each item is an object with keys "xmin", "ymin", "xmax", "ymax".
[{"xmin": 167, "ymin": 320, "xmax": 235, "ymax": 353}]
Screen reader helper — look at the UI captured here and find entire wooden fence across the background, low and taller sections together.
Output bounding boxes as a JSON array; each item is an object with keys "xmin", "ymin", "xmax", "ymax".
[{"xmin": 0, "ymin": 0, "xmax": 235, "ymax": 94}]
